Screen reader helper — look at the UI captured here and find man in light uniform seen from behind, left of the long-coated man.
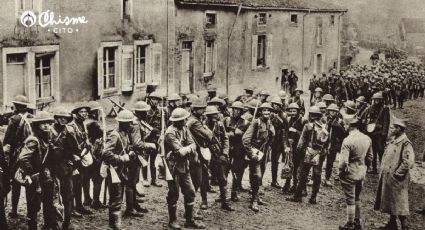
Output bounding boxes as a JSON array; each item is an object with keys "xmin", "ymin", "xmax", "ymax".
[{"xmin": 339, "ymin": 115, "xmax": 372, "ymax": 230}]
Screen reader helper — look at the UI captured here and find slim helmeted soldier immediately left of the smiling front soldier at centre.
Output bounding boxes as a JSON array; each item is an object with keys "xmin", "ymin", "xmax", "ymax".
[{"xmin": 224, "ymin": 101, "xmax": 247, "ymax": 202}]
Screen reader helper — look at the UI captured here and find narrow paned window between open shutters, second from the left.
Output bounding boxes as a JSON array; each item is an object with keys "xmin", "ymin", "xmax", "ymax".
[{"xmin": 103, "ymin": 47, "xmax": 117, "ymax": 89}]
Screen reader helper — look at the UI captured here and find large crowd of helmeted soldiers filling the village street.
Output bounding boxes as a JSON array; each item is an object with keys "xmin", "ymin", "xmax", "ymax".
[{"xmin": 0, "ymin": 56, "xmax": 424, "ymax": 229}]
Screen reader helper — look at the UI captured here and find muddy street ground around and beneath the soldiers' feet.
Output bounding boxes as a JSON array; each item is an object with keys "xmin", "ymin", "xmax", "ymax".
[{"xmin": 0, "ymin": 100, "xmax": 425, "ymax": 230}]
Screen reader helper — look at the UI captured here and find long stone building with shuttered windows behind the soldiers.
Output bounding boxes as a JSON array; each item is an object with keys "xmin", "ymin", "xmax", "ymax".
[{"xmin": 0, "ymin": 0, "xmax": 346, "ymax": 108}]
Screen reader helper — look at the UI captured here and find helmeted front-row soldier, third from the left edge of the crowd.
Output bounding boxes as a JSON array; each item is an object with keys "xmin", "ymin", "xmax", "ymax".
[{"xmin": 51, "ymin": 107, "xmax": 80, "ymax": 230}]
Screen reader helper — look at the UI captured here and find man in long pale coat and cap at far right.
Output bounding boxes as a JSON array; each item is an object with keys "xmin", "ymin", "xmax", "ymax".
[{"xmin": 375, "ymin": 118, "xmax": 415, "ymax": 230}]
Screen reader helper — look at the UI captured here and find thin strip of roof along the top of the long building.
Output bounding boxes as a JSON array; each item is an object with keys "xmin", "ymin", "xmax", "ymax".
[{"xmin": 176, "ymin": 0, "xmax": 347, "ymax": 12}]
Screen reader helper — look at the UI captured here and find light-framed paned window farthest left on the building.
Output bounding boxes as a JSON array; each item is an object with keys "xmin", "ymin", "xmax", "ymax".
[{"xmin": 35, "ymin": 55, "xmax": 52, "ymax": 99}]
